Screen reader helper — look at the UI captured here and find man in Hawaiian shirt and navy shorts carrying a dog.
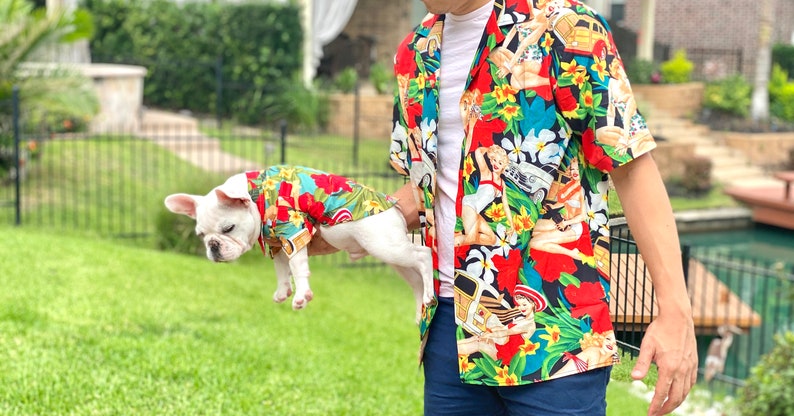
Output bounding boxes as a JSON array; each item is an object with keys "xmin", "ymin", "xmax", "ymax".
[{"xmin": 391, "ymin": 0, "xmax": 697, "ymax": 416}]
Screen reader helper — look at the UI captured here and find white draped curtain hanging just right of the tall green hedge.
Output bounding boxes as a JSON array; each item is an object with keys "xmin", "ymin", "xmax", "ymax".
[{"xmin": 309, "ymin": 0, "xmax": 358, "ymax": 79}]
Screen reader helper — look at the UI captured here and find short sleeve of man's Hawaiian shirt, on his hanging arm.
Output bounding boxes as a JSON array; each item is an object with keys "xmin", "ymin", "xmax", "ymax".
[{"xmin": 554, "ymin": 7, "xmax": 656, "ymax": 172}]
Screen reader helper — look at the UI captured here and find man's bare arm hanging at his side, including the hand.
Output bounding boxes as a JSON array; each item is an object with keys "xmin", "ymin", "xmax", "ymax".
[{"xmin": 611, "ymin": 154, "xmax": 698, "ymax": 416}]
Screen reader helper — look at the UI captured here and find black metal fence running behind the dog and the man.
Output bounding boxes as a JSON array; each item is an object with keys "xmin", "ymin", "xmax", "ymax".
[{"xmin": 0, "ymin": 88, "xmax": 794, "ymax": 394}]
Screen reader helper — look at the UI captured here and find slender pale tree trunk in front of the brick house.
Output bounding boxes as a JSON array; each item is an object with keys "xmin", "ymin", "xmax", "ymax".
[{"xmin": 750, "ymin": 0, "xmax": 775, "ymax": 122}]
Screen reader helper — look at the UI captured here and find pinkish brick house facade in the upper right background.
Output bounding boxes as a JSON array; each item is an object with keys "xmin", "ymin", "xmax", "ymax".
[{"xmin": 617, "ymin": 0, "xmax": 794, "ymax": 79}]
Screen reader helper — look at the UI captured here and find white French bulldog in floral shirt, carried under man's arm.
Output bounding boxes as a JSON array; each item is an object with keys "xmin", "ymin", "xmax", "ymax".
[{"xmin": 165, "ymin": 165, "xmax": 433, "ymax": 321}]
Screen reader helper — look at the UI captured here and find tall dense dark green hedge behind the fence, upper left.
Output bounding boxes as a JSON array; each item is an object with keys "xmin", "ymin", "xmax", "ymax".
[{"xmin": 83, "ymin": 0, "xmax": 306, "ymax": 124}]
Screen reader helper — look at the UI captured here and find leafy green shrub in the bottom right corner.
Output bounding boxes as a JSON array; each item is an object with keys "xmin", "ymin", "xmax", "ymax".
[{"xmin": 739, "ymin": 332, "xmax": 794, "ymax": 416}]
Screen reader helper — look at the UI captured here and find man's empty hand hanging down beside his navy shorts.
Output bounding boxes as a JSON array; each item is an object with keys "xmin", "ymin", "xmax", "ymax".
[{"xmin": 631, "ymin": 310, "xmax": 698, "ymax": 416}]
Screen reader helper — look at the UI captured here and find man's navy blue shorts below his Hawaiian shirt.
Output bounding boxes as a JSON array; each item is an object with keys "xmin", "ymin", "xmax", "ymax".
[{"xmin": 423, "ymin": 298, "xmax": 611, "ymax": 416}]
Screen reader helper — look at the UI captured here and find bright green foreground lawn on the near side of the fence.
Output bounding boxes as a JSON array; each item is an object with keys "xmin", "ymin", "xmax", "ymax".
[{"xmin": 0, "ymin": 227, "xmax": 647, "ymax": 416}]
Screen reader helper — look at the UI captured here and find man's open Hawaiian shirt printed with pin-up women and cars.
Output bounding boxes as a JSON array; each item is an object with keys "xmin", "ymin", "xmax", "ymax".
[{"xmin": 390, "ymin": 0, "xmax": 655, "ymax": 385}]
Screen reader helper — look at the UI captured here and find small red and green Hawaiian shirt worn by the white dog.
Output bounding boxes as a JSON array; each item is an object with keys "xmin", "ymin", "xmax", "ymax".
[{"xmin": 245, "ymin": 166, "xmax": 396, "ymax": 257}]
